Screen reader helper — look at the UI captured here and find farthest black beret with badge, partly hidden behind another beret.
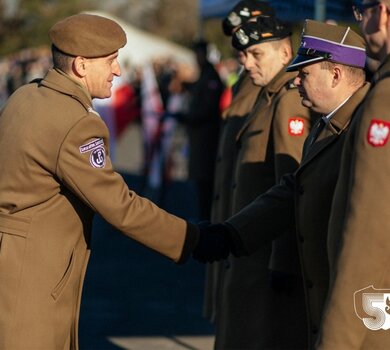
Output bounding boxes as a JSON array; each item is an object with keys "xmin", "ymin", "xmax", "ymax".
[{"xmin": 222, "ymin": 0, "xmax": 274, "ymax": 36}]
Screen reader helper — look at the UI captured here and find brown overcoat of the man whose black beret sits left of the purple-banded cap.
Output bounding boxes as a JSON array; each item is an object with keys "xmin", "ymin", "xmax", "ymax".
[{"xmin": 216, "ymin": 67, "xmax": 310, "ymax": 350}]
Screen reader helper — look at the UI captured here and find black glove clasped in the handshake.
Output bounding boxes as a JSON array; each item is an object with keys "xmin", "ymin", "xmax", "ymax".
[{"xmin": 192, "ymin": 222, "xmax": 233, "ymax": 263}]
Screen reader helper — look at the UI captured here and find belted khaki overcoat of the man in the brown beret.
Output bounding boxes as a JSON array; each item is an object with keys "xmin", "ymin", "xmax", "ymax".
[{"xmin": 0, "ymin": 70, "xmax": 198, "ymax": 350}]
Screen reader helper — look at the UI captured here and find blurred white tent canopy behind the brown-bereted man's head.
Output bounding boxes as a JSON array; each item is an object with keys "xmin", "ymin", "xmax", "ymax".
[{"xmin": 88, "ymin": 11, "xmax": 194, "ymax": 66}]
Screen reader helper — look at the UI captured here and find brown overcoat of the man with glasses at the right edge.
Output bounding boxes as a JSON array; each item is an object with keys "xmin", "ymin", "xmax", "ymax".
[{"xmin": 319, "ymin": 56, "xmax": 390, "ymax": 350}]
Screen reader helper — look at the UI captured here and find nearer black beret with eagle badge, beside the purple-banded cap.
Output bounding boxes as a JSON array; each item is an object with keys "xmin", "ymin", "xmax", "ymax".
[{"xmin": 232, "ymin": 17, "xmax": 291, "ymax": 51}]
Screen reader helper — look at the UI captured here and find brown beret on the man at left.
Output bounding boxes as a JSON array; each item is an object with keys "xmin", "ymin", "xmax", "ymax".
[{"xmin": 49, "ymin": 13, "xmax": 127, "ymax": 58}]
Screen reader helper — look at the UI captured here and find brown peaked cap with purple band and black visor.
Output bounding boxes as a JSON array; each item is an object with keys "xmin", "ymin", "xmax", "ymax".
[{"xmin": 286, "ymin": 19, "xmax": 366, "ymax": 72}]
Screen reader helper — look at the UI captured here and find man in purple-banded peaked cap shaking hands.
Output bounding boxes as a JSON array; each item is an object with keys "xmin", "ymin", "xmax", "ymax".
[{"xmin": 193, "ymin": 20, "xmax": 369, "ymax": 349}]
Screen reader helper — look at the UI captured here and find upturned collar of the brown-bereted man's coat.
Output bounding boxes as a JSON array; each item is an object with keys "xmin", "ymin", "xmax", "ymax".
[{"xmin": 41, "ymin": 69, "xmax": 92, "ymax": 111}]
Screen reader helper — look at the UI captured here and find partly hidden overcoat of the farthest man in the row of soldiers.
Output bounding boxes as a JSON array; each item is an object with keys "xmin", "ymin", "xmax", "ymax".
[{"xmin": 203, "ymin": 71, "xmax": 261, "ymax": 322}]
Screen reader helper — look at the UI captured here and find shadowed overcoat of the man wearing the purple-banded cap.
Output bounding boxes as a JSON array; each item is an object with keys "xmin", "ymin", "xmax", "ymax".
[{"xmin": 228, "ymin": 84, "xmax": 369, "ymax": 344}]
